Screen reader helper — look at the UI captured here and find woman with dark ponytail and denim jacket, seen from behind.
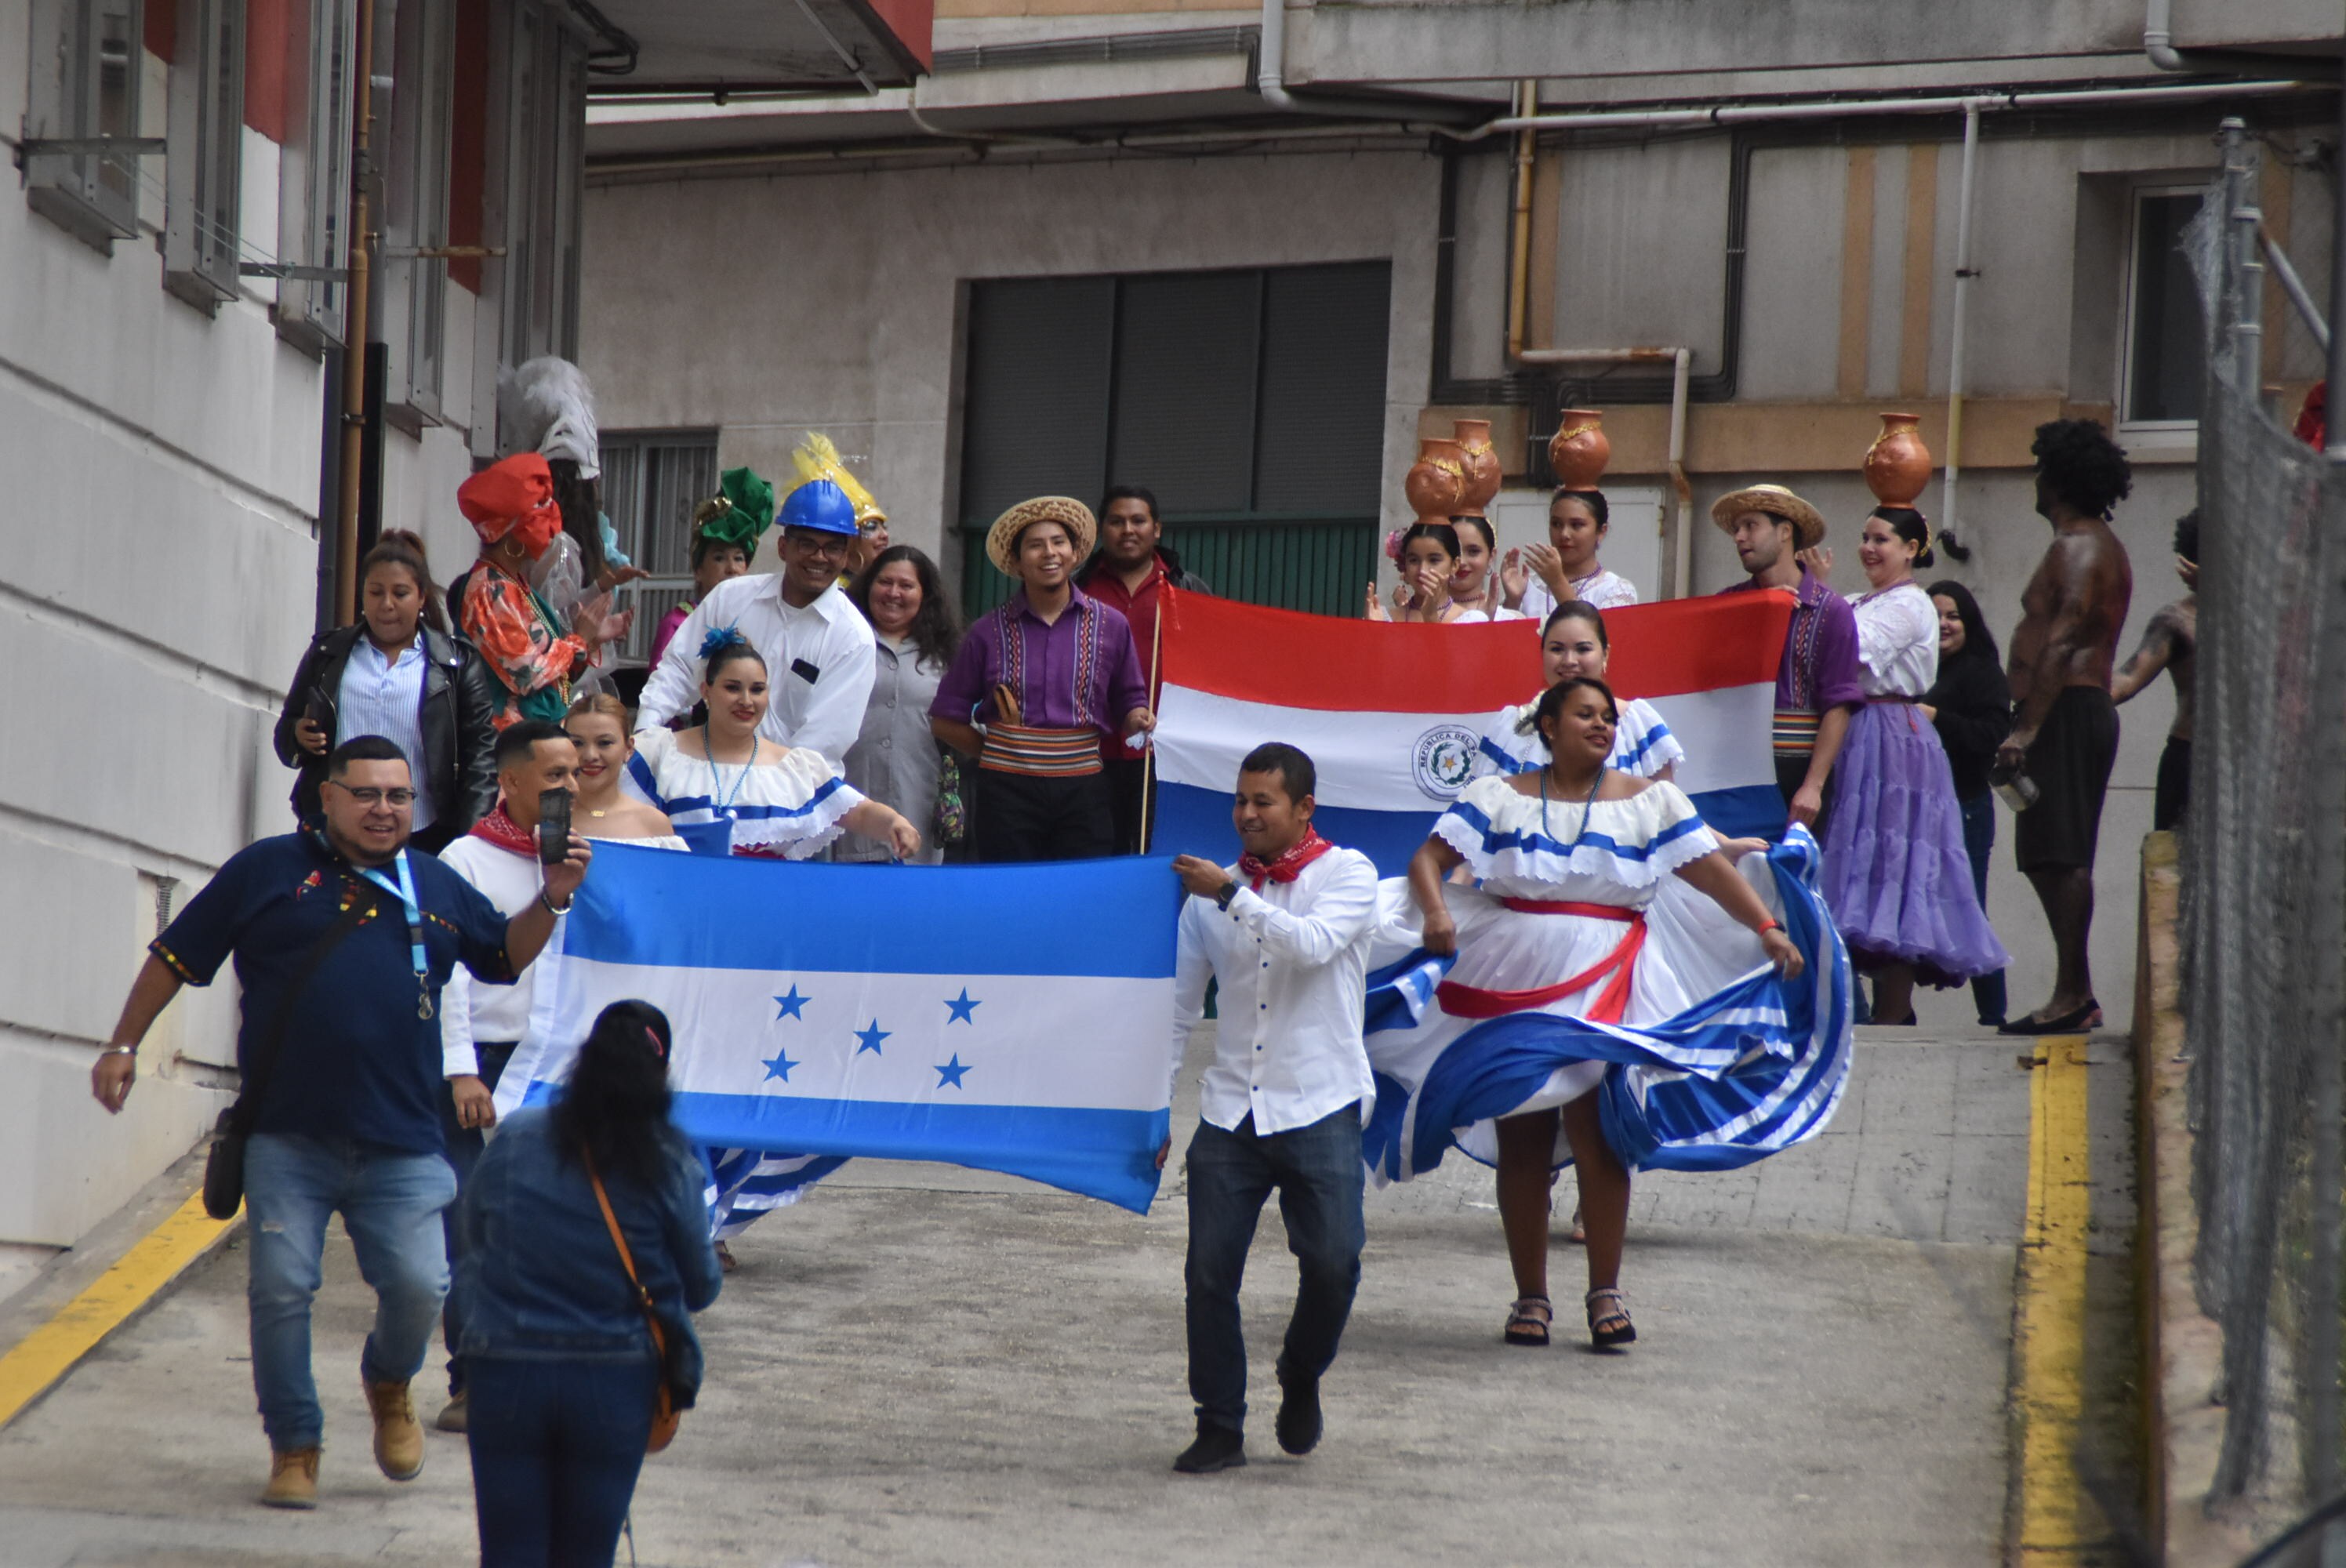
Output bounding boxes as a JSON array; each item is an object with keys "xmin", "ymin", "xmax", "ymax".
[{"xmin": 457, "ymin": 1002, "xmax": 721, "ymax": 1568}]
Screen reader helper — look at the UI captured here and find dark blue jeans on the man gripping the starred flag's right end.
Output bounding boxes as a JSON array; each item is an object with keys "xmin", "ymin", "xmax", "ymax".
[{"xmin": 1185, "ymin": 1101, "xmax": 1367, "ymax": 1432}]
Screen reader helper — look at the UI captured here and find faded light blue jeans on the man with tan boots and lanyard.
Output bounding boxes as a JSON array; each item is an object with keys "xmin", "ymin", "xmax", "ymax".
[{"xmin": 244, "ymin": 1134, "xmax": 455, "ymax": 1453}]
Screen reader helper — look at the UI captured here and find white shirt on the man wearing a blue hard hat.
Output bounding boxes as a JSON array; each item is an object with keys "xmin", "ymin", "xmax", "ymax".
[{"xmin": 636, "ymin": 573, "xmax": 875, "ymax": 768}]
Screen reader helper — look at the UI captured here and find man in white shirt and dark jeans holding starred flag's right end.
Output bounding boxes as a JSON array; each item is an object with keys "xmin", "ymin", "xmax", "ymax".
[{"xmin": 1157, "ymin": 742, "xmax": 1377, "ymax": 1474}]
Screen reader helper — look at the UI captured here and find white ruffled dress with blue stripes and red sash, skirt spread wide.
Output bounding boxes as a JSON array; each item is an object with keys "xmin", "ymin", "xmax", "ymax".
[{"xmin": 1365, "ymin": 777, "xmax": 1851, "ymax": 1181}]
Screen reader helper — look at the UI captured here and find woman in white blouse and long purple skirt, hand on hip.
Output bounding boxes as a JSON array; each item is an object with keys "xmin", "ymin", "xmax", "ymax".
[{"xmin": 1821, "ymin": 507, "xmax": 2006, "ymax": 1023}]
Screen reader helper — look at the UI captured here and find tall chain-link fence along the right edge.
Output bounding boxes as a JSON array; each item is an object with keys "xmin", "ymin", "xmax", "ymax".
[{"xmin": 2182, "ymin": 122, "xmax": 2346, "ymax": 1535}]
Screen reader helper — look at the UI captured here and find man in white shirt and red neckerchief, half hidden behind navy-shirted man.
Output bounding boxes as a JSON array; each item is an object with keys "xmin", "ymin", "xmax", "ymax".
[{"xmin": 437, "ymin": 718, "xmax": 579, "ymax": 1432}]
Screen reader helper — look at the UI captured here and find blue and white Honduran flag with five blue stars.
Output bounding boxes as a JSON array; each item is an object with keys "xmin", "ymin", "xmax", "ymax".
[{"xmin": 497, "ymin": 843, "xmax": 1180, "ymax": 1214}]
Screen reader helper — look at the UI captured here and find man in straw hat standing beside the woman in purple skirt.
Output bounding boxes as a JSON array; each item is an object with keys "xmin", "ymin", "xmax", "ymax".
[{"xmin": 1710, "ymin": 484, "xmax": 1865, "ymax": 831}]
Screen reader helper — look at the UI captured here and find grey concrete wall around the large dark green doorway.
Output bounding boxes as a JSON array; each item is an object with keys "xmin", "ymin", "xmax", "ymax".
[{"xmin": 582, "ymin": 153, "xmax": 1438, "ymax": 575}]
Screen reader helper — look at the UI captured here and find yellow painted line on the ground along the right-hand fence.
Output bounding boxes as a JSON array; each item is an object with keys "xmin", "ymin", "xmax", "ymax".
[{"xmin": 2015, "ymin": 1035, "xmax": 2109, "ymax": 1568}]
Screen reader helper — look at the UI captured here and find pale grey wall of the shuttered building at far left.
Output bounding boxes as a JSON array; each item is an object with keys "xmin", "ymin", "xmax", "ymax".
[{"xmin": 0, "ymin": 0, "xmax": 488, "ymax": 1247}]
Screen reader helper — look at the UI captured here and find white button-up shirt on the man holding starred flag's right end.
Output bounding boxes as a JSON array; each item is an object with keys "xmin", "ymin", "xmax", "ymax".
[{"xmin": 1173, "ymin": 850, "xmax": 1377, "ymax": 1134}]
